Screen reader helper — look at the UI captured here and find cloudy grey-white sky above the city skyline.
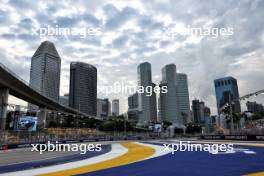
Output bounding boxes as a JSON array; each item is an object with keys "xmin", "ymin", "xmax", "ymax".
[{"xmin": 0, "ymin": 0, "xmax": 264, "ymax": 112}]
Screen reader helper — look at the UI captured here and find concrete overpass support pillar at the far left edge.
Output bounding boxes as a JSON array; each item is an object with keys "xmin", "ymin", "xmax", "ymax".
[{"xmin": 0, "ymin": 88, "xmax": 9, "ymax": 130}]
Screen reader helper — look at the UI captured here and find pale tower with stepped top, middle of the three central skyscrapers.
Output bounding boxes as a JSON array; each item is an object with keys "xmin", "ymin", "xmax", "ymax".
[{"xmin": 160, "ymin": 64, "xmax": 183, "ymax": 125}]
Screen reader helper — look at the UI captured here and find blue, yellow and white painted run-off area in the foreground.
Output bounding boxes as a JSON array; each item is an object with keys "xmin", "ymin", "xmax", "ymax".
[{"xmin": 0, "ymin": 141, "xmax": 264, "ymax": 176}]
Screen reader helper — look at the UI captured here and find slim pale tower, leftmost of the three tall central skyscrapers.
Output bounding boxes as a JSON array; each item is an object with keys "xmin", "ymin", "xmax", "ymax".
[{"xmin": 137, "ymin": 62, "xmax": 157, "ymax": 125}]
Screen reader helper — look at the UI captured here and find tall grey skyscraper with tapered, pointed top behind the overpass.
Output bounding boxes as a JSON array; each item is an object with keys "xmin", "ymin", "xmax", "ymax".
[{"xmin": 29, "ymin": 41, "xmax": 61, "ymax": 110}]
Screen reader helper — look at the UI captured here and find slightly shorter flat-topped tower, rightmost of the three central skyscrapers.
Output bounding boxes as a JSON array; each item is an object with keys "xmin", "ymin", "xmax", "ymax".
[{"xmin": 176, "ymin": 73, "xmax": 191, "ymax": 124}]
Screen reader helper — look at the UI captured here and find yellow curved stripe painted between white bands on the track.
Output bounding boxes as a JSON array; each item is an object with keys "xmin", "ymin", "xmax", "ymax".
[{"xmin": 39, "ymin": 142, "xmax": 155, "ymax": 176}]
